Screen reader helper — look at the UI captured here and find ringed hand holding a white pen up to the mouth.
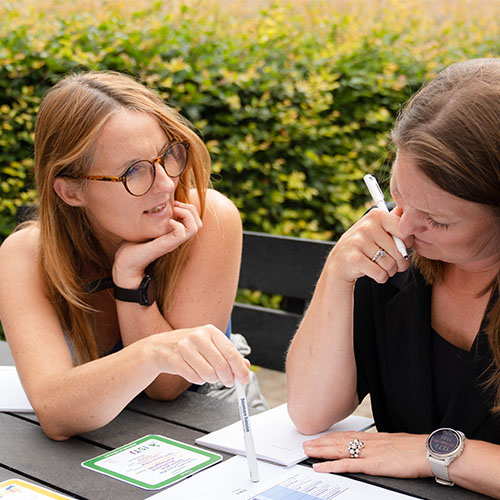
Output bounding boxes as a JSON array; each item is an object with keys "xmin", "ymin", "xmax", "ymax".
[{"xmin": 327, "ymin": 208, "xmax": 413, "ymax": 283}]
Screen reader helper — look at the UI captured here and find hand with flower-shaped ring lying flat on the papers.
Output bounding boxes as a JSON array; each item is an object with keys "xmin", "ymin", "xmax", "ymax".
[{"xmin": 304, "ymin": 432, "xmax": 432, "ymax": 478}]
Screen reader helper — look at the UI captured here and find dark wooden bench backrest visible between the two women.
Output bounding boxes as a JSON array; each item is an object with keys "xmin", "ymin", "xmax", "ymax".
[{"xmin": 232, "ymin": 231, "xmax": 334, "ymax": 371}]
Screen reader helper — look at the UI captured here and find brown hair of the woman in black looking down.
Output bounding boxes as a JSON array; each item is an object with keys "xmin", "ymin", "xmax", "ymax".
[{"xmin": 392, "ymin": 59, "xmax": 500, "ymax": 412}]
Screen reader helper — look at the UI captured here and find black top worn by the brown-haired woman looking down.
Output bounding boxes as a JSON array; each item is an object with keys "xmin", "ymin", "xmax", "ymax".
[{"xmin": 354, "ymin": 267, "xmax": 500, "ymax": 444}]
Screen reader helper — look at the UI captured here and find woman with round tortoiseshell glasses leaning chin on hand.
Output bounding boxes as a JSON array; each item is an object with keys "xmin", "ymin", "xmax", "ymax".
[{"xmin": 0, "ymin": 72, "xmax": 249, "ymax": 439}]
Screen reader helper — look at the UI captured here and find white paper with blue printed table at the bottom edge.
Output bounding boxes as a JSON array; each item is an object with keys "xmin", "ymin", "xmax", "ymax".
[{"xmin": 149, "ymin": 456, "xmax": 413, "ymax": 500}]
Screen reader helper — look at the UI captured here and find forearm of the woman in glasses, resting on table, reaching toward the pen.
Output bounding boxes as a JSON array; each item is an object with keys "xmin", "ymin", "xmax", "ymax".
[{"xmin": 30, "ymin": 342, "xmax": 158, "ymax": 440}]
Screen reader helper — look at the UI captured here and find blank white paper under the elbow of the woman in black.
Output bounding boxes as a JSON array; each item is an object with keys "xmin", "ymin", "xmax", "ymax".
[{"xmin": 196, "ymin": 403, "xmax": 373, "ymax": 466}]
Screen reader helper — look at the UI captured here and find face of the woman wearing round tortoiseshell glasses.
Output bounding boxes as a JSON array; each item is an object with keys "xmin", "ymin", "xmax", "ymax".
[{"xmin": 78, "ymin": 110, "xmax": 179, "ymax": 250}]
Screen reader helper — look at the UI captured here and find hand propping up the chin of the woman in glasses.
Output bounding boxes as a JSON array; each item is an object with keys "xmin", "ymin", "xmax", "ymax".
[{"xmin": 113, "ymin": 201, "xmax": 202, "ymax": 288}]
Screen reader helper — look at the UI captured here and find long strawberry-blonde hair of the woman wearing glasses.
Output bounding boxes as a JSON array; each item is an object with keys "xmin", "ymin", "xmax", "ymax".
[{"xmin": 35, "ymin": 71, "xmax": 210, "ymax": 362}]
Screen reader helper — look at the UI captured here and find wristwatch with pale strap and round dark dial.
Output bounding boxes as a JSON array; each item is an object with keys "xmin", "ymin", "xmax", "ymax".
[{"xmin": 425, "ymin": 428, "xmax": 465, "ymax": 486}]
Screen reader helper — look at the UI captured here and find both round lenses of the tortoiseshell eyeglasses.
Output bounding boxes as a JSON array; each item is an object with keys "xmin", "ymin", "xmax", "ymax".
[{"xmin": 125, "ymin": 142, "xmax": 187, "ymax": 196}]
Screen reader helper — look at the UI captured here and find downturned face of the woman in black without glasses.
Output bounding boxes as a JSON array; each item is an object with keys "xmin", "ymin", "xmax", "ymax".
[{"xmin": 391, "ymin": 151, "xmax": 498, "ymax": 270}]
